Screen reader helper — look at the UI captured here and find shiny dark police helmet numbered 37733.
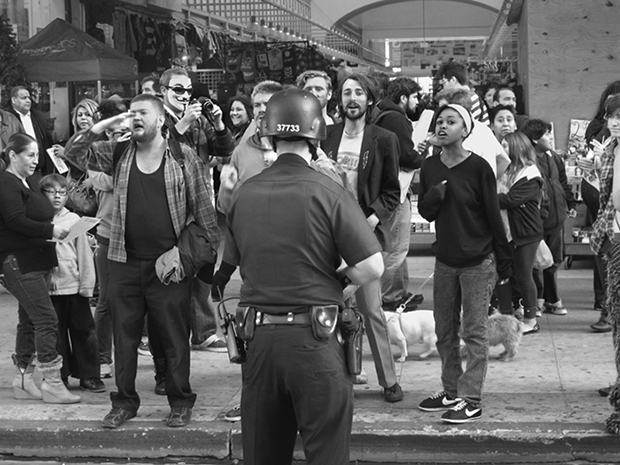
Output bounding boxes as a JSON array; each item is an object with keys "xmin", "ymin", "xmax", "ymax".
[{"xmin": 260, "ymin": 88, "xmax": 327, "ymax": 140}]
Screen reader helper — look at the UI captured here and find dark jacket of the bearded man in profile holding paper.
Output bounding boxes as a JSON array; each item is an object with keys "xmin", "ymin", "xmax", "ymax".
[{"xmin": 375, "ymin": 98, "xmax": 422, "ymax": 171}]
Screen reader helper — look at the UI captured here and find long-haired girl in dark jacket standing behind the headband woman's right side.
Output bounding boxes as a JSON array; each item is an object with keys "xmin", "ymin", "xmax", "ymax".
[{"xmin": 498, "ymin": 132, "xmax": 543, "ymax": 334}]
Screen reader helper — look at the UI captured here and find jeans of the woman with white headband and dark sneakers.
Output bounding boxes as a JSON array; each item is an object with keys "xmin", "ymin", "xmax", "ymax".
[{"xmin": 433, "ymin": 254, "xmax": 497, "ymax": 404}]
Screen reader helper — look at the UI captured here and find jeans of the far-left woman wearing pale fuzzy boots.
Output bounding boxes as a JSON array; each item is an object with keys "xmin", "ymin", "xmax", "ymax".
[{"xmin": 2, "ymin": 254, "xmax": 58, "ymax": 368}]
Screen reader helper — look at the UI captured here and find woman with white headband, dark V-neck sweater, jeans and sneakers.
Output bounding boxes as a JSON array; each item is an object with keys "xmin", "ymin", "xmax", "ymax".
[{"xmin": 418, "ymin": 104, "xmax": 511, "ymax": 423}]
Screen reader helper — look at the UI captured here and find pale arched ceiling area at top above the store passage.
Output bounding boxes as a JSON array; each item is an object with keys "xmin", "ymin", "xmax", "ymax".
[{"xmin": 312, "ymin": 0, "xmax": 504, "ymax": 43}]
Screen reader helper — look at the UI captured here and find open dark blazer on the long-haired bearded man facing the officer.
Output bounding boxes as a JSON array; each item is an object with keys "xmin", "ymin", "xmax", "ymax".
[{"xmin": 321, "ymin": 123, "xmax": 400, "ymax": 248}]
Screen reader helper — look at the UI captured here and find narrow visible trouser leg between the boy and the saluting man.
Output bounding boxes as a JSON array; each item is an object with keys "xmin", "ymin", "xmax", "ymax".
[{"xmin": 95, "ymin": 236, "xmax": 112, "ymax": 363}]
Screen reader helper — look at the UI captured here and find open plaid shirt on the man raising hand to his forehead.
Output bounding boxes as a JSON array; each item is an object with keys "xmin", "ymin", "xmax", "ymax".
[{"xmin": 65, "ymin": 131, "xmax": 220, "ymax": 263}]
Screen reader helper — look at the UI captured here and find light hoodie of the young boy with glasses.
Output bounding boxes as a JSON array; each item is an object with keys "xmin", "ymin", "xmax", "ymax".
[{"xmin": 49, "ymin": 208, "xmax": 96, "ymax": 297}]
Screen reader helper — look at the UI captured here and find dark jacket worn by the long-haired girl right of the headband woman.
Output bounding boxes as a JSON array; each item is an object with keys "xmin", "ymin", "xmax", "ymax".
[{"xmin": 497, "ymin": 166, "xmax": 543, "ymax": 247}]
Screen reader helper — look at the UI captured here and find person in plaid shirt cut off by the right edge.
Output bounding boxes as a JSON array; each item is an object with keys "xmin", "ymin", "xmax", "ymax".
[{"xmin": 590, "ymin": 95, "xmax": 620, "ymax": 434}]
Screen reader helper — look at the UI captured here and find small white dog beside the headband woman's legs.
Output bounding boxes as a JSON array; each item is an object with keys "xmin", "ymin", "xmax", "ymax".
[{"xmin": 385, "ymin": 310, "xmax": 437, "ymax": 362}]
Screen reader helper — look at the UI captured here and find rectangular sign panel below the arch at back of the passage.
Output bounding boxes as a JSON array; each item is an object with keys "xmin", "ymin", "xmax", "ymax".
[{"xmin": 400, "ymin": 40, "xmax": 483, "ymax": 69}]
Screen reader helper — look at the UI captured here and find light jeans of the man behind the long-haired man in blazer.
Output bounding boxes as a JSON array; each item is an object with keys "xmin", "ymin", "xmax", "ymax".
[{"xmin": 381, "ymin": 198, "xmax": 411, "ymax": 311}]
